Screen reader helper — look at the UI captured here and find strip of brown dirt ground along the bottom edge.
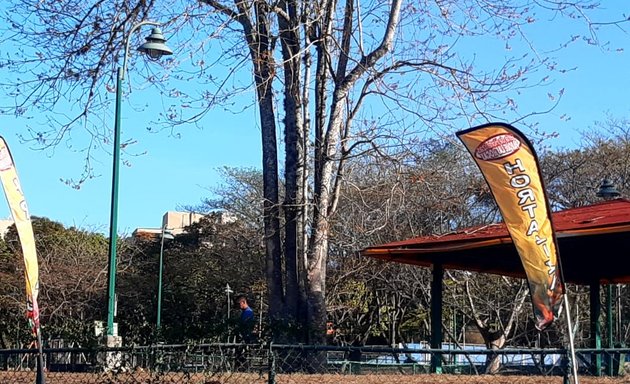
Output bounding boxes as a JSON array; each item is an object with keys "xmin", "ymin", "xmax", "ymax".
[{"xmin": 0, "ymin": 371, "xmax": 630, "ymax": 384}]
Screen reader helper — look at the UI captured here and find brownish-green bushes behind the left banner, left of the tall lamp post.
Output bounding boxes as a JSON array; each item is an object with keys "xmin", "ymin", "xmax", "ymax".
[{"xmin": 0, "ymin": 217, "xmax": 107, "ymax": 346}]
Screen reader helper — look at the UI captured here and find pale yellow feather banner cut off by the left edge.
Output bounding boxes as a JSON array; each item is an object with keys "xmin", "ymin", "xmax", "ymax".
[{"xmin": 0, "ymin": 137, "xmax": 39, "ymax": 333}]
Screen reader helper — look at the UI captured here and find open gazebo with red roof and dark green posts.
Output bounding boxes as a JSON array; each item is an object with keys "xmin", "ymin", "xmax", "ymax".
[{"xmin": 361, "ymin": 199, "xmax": 630, "ymax": 374}]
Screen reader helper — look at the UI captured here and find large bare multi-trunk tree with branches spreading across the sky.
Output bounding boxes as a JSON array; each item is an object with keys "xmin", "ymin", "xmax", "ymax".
[{"xmin": 0, "ymin": 0, "xmax": 624, "ymax": 342}]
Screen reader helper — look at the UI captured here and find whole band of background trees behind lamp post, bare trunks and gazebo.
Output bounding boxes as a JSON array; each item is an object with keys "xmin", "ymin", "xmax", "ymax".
[{"xmin": 0, "ymin": 128, "xmax": 630, "ymax": 348}]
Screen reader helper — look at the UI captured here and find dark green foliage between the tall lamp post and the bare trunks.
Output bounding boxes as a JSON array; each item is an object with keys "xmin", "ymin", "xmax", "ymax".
[{"xmin": 118, "ymin": 214, "xmax": 264, "ymax": 343}]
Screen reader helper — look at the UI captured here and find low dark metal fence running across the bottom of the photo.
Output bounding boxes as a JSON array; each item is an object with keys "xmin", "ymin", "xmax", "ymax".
[{"xmin": 0, "ymin": 344, "xmax": 630, "ymax": 384}]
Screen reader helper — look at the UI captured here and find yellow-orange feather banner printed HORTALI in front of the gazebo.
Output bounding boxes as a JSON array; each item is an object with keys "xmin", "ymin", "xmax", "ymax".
[{"xmin": 457, "ymin": 123, "xmax": 564, "ymax": 330}]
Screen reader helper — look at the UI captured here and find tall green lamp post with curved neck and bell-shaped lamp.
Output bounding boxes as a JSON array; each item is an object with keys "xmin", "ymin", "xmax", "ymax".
[{"xmin": 107, "ymin": 21, "xmax": 173, "ymax": 343}]
